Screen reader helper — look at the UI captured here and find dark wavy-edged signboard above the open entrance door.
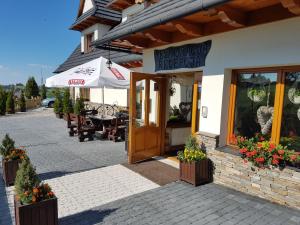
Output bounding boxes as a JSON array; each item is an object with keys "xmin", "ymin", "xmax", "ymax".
[{"xmin": 154, "ymin": 40, "xmax": 211, "ymax": 71}]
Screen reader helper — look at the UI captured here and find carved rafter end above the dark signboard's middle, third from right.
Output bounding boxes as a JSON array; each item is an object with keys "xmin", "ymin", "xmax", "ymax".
[{"xmin": 167, "ymin": 20, "xmax": 203, "ymax": 37}]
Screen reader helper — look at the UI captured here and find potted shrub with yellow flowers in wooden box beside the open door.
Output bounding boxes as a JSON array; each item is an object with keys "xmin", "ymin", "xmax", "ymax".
[{"xmin": 178, "ymin": 136, "xmax": 211, "ymax": 186}]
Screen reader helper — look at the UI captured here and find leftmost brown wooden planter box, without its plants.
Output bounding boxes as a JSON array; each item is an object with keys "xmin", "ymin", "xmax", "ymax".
[{"xmin": 2, "ymin": 159, "xmax": 21, "ymax": 186}]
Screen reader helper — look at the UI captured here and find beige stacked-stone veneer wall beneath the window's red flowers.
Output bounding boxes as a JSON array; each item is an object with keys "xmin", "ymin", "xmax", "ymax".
[{"xmin": 198, "ymin": 133, "xmax": 300, "ymax": 209}]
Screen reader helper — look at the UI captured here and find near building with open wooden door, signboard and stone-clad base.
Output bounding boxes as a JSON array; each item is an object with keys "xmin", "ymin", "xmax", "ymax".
[{"xmin": 93, "ymin": 0, "xmax": 300, "ymax": 208}]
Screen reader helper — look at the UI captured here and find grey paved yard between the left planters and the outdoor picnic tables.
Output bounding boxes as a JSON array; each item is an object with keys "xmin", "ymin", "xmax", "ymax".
[{"xmin": 0, "ymin": 109, "xmax": 127, "ymax": 179}]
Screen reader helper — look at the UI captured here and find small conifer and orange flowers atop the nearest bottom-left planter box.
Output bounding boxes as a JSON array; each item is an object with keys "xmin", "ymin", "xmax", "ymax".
[{"xmin": 15, "ymin": 158, "xmax": 55, "ymax": 204}]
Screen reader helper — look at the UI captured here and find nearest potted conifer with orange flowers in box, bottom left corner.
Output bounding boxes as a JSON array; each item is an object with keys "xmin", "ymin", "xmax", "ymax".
[{"xmin": 14, "ymin": 158, "xmax": 58, "ymax": 225}]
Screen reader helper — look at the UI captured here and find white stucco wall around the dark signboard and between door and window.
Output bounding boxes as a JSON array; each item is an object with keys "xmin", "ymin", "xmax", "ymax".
[{"xmin": 143, "ymin": 17, "xmax": 300, "ymax": 145}]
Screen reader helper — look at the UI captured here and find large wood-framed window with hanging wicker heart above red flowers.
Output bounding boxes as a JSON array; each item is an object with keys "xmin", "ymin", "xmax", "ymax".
[{"xmin": 228, "ymin": 67, "xmax": 300, "ymax": 152}]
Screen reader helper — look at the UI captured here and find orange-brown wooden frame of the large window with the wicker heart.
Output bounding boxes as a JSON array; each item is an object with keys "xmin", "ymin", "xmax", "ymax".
[{"xmin": 227, "ymin": 66, "xmax": 300, "ymax": 145}]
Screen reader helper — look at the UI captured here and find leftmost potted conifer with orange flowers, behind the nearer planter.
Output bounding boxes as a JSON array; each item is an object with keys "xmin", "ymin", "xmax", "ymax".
[{"xmin": 0, "ymin": 134, "xmax": 26, "ymax": 186}]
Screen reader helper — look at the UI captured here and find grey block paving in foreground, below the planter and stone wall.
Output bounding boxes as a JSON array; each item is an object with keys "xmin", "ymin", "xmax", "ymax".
[{"xmin": 60, "ymin": 182, "xmax": 300, "ymax": 225}]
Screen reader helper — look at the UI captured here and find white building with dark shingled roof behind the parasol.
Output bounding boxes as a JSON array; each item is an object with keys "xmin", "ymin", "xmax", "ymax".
[{"xmin": 54, "ymin": 0, "xmax": 143, "ymax": 107}]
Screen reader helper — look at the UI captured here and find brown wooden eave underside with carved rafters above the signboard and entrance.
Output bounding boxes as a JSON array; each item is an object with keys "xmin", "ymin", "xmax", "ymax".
[{"xmin": 106, "ymin": 0, "xmax": 300, "ymax": 52}]
